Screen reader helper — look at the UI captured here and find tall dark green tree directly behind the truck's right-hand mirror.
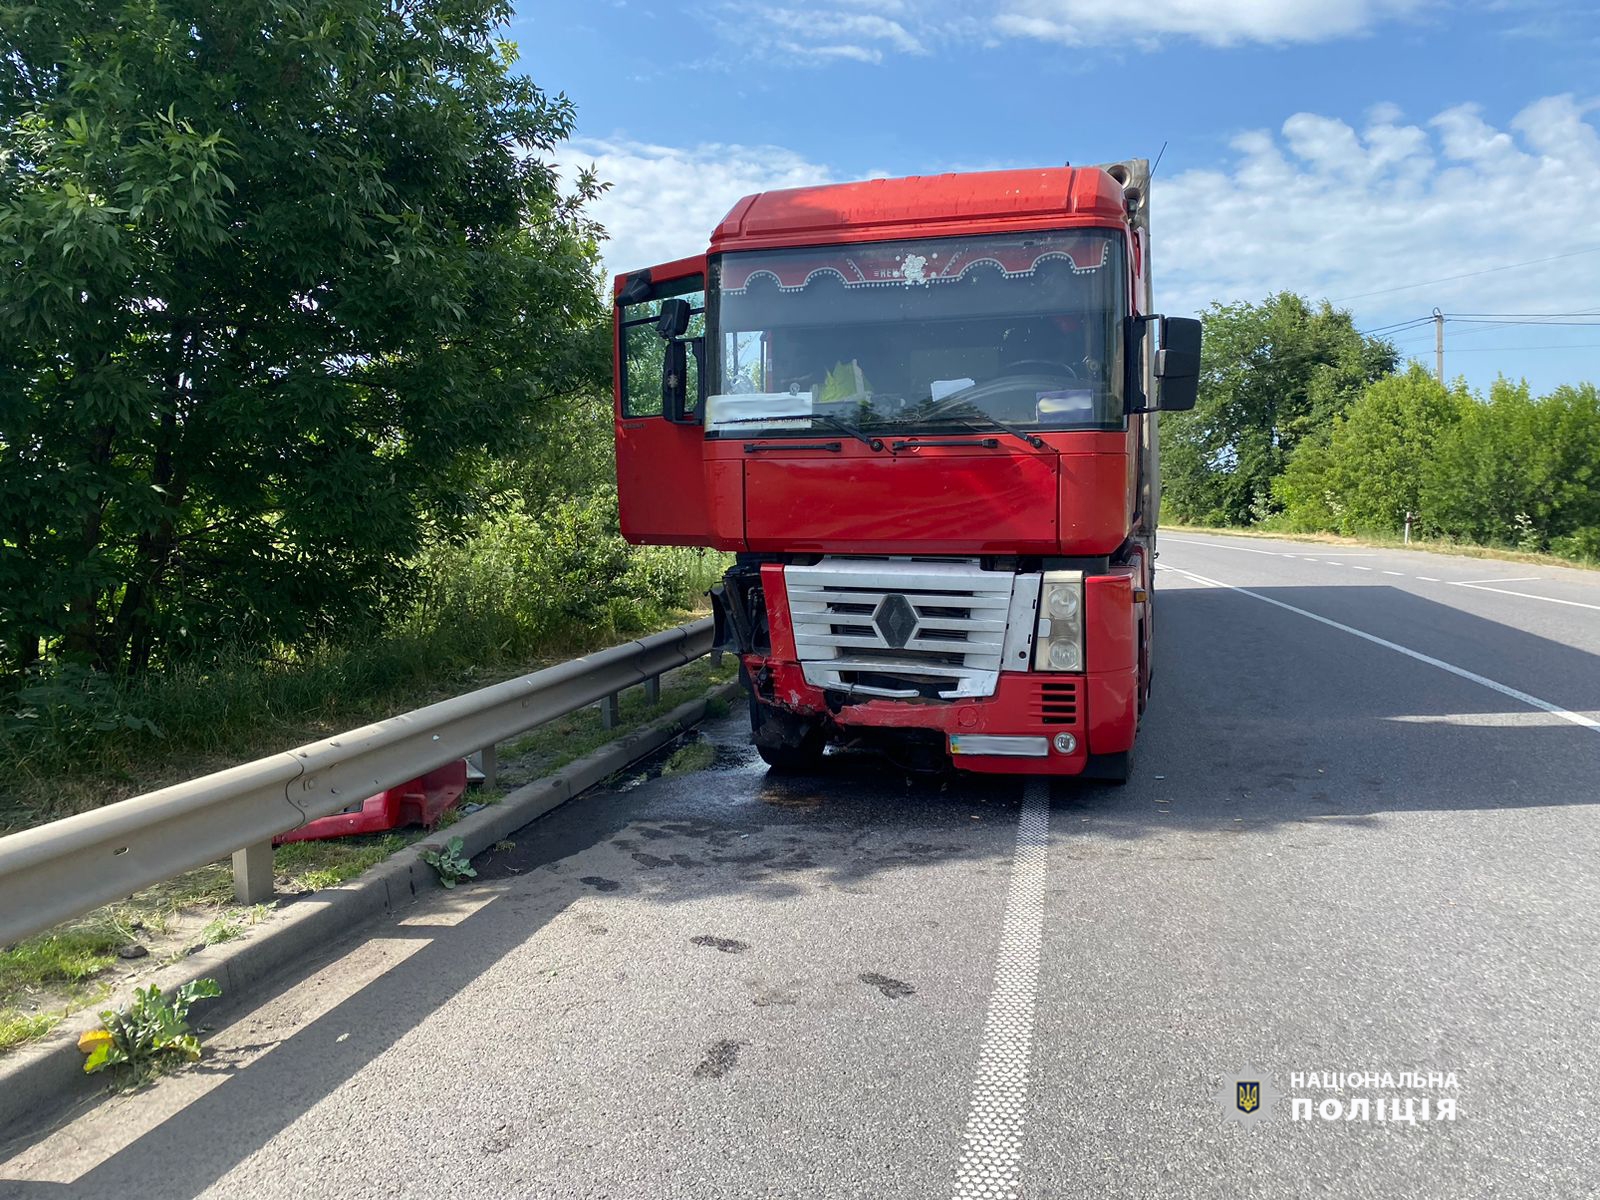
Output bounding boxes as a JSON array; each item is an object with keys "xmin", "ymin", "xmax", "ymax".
[{"xmin": 1162, "ymin": 291, "xmax": 1397, "ymax": 525}]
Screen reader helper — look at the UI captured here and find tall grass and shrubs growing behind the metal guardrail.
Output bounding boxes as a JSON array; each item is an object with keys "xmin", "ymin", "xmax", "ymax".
[{"xmin": 0, "ymin": 493, "xmax": 726, "ymax": 830}]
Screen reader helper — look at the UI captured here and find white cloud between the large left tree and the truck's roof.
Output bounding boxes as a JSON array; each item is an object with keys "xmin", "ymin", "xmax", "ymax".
[{"xmin": 558, "ymin": 139, "xmax": 837, "ymax": 274}]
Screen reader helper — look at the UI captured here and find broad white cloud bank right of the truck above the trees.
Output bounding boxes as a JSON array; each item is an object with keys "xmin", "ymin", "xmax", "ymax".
[{"xmin": 1152, "ymin": 96, "xmax": 1600, "ymax": 323}]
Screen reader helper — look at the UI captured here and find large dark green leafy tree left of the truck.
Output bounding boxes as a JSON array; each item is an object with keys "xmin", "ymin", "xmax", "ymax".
[{"xmin": 0, "ymin": 0, "xmax": 606, "ymax": 669}]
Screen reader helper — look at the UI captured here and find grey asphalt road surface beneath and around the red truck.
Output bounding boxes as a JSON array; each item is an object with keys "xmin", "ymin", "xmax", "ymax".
[{"xmin": 0, "ymin": 534, "xmax": 1600, "ymax": 1200}]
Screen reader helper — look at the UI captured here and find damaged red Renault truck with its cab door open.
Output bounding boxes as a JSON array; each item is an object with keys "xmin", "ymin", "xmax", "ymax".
[{"xmin": 616, "ymin": 160, "xmax": 1200, "ymax": 781}]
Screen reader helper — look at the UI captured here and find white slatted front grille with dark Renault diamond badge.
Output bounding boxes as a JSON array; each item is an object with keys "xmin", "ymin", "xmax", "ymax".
[{"xmin": 784, "ymin": 558, "xmax": 1016, "ymax": 699}]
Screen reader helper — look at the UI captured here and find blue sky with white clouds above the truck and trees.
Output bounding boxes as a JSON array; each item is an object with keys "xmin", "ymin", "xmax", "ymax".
[{"xmin": 510, "ymin": 0, "xmax": 1600, "ymax": 390}]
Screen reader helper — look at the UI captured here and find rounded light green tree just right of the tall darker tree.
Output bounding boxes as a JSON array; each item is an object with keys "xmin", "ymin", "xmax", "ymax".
[{"xmin": 1272, "ymin": 363, "xmax": 1472, "ymax": 533}]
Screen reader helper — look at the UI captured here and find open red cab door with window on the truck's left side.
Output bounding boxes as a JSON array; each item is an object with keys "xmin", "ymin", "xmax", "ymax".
[{"xmin": 614, "ymin": 258, "xmax": 712, "ymax": 546}]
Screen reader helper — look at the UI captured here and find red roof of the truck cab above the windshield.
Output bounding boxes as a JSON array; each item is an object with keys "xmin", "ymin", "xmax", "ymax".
[{"xmin": 710, "ymin": 166, "xmax": 1126, "ymax": 254}]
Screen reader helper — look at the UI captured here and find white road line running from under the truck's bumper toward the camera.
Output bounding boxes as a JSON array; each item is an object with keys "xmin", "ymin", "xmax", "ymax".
[{"xmin": 952, "ymin": 779, "xmax": 1050, "ymax": 1200}]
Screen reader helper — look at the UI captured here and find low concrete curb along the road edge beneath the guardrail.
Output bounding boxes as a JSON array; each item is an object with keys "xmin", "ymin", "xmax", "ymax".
[{"xmin": 0, "ymin": 682, "xmax": 742, "ymax": 1142}]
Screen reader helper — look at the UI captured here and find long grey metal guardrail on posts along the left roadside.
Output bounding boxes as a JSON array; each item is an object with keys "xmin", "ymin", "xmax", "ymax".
[{"xmin": 0, "ymin": 618, "xmax": 712, "ymax": 946}]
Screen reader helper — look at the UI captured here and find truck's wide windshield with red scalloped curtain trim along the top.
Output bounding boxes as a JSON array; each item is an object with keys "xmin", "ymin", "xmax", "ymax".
[{"xmin": 706, "ymin": 230, "xmax": 1126, "ymax": 437}]
